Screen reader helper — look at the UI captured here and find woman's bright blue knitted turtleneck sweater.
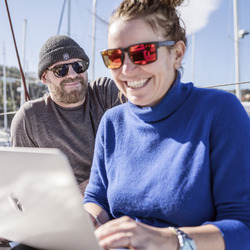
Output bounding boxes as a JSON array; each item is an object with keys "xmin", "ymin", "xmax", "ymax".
[{"xmin": 84, "ymin": 79, "xmax": 250, "ymax": 250}]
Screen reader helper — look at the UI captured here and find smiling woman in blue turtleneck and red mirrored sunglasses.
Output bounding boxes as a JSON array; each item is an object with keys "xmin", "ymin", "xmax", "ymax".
[{"xmin": 84, "ymin": 0, "xmax": 250, "ymax": 250}]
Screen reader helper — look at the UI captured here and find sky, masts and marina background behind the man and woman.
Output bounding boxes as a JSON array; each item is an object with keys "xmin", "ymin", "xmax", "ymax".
[{"xmin": 0, "ymin": 0, "xmax": 250, "ymax": 145}]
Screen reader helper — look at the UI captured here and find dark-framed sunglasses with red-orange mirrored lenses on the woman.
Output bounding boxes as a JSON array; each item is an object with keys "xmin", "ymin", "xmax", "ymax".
[{"xmin": 101, "ymin": 41, "xmax": 175, "ymax": 69}]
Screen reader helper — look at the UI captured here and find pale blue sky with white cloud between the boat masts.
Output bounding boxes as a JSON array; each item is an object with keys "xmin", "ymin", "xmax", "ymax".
[{"xmin": 0, "ymin": 0, "xmax": 250, "ymax": 92}]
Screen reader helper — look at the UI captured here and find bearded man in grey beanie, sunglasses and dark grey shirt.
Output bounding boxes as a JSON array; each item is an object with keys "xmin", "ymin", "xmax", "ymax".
[{"xmin": 11, "ymin": 35, "xmax": 120, "ymax": 193}]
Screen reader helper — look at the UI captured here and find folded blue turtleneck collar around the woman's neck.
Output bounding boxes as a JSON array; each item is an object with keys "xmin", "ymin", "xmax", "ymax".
[{"xmin": 128, "ymin": 74, "xmax": 193, "ymax": 122}]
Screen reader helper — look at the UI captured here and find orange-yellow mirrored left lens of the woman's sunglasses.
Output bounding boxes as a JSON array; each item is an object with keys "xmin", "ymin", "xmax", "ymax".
[{"xmin": 102, "ymin": 49, "xmax": 123, "ymax": 69}]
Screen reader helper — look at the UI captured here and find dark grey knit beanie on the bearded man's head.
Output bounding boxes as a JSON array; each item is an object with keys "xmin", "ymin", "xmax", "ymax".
[{"xmin": 38, "ymin": 35, "xmax": 89, "ymax": 79}]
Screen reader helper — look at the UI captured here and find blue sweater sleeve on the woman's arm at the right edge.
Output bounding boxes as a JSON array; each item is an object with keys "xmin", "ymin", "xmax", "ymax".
[{"xmin": 205, "ymin": 94, "xmax": 250, "ymax": 250}]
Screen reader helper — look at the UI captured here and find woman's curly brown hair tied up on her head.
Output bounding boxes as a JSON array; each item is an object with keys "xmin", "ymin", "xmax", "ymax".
[{"xmin": 109, "ymin": 0, "xmax": 187, "ymax": 45}]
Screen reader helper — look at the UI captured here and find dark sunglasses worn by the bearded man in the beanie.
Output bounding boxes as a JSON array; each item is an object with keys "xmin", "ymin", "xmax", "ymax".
[{"xmin": 47, "ymin": 61, "xmax": 89, "ymax": 78}]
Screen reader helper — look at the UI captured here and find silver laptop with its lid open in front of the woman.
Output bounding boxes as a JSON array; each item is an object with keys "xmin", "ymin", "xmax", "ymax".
[{"xmin": 0, "ymin": 147, "xmax": 101, "ymax": 250}]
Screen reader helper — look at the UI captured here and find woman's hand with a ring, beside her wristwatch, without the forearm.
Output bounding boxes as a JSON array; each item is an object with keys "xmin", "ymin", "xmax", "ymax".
[{"xmin": 95, "ymin": 216, "xmax": 178, "ymax": 250}]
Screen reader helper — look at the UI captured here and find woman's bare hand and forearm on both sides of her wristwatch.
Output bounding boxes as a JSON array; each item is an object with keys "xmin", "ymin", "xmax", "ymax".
[{"xmin": 95, "ymin": 216, "xmax": 225, "ymax": 250}]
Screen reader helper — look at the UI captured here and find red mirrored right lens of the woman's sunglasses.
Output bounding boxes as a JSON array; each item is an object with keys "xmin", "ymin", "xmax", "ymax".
[{"xmin": 129, "ymin": 43, "xmax": 157, "ymax": 65}]
